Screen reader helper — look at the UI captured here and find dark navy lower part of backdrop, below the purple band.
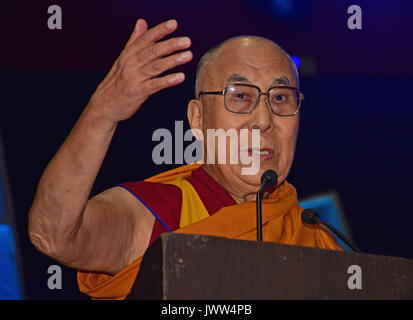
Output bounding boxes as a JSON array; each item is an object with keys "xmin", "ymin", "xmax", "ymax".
[{"xmin": 0, "ymin": 70, "xmax": 413, "ymax": 298}]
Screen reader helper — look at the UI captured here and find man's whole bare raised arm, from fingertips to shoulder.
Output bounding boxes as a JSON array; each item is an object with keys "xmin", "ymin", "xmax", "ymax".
[{"xmin": 29, "ymin": 19, "xmax": 192, "ymax": 272}]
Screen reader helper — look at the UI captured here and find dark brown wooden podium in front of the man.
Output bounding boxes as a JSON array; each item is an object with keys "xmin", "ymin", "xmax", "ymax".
[{"xmin": 128, "ymin": 233, "xmax": 413, "ymax": 300}]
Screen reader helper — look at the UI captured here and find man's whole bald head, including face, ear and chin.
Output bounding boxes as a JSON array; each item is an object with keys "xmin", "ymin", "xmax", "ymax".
[{"xmin": 188, "ymin": 36, "xmax": 299, "ymax": 202}]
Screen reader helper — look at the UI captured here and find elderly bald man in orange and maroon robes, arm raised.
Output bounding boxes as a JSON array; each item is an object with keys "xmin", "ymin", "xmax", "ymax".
[{"xmin": 29, "ymin": 19, "xmax": 340, "ymax": 299}]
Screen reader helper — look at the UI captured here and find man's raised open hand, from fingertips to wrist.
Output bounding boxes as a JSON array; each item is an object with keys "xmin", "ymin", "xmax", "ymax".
[{"xmin": 90, "ymin": 19, "xmax": 192, "ymax": 122}]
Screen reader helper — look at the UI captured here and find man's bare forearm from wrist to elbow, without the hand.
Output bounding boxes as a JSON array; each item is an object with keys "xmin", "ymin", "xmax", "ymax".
[{"xmin": 29, "ymin": 104, "xmax": 117, "ymax": 256}]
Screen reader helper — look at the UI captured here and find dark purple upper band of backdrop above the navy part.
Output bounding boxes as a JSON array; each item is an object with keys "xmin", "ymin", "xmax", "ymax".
[{"xmin": 0, "ymin": 0, "xmax": 413, "ymax": 76}]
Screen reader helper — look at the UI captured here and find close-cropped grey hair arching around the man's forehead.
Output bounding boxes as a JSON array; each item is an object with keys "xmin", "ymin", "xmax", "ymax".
[{"xmin": 195, "ymin": 36, "xmax": 299, "ymax": 98}]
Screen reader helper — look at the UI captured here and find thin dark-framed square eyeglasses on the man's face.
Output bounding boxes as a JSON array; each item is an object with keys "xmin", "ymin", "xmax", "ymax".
[{"xmin": 197, "ymin": 83, "xmax": 304, "ymax": 117}]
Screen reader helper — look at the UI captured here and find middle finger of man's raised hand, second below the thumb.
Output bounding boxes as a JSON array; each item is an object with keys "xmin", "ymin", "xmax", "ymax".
[{"xmin": 138, "ymin": 37, "xmax": 191, "ymax": 61}]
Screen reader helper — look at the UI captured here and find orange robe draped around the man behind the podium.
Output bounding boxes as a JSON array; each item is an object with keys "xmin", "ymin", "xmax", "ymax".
[{"xmin": 78, "ymin": 164, "xmax": 342, "ymax": 299}]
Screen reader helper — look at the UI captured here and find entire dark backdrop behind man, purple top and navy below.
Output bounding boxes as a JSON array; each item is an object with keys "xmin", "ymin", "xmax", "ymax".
[{"xmin": 0, "ymin": 0, "xmax": 413, "ymax": 299}]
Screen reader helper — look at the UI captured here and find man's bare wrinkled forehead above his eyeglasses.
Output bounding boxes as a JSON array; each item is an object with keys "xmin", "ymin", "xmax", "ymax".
[{"xmin": 210, "ymin": 37, "xmax": 294, "ymax": 86}]
